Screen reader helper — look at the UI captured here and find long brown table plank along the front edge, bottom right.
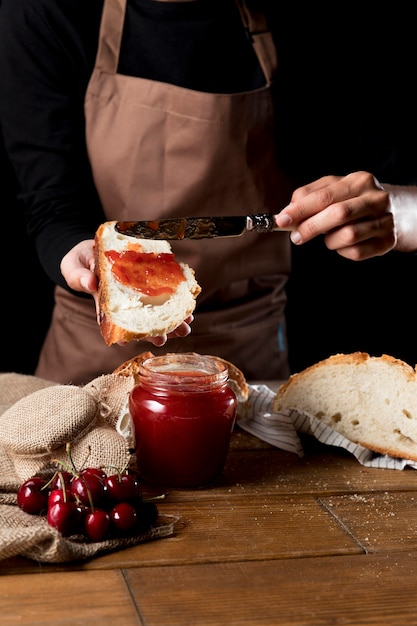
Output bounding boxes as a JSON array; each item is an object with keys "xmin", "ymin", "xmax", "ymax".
[{"xmin": 126, "ymin": 552, "xmax": 417, "ymax": 626}]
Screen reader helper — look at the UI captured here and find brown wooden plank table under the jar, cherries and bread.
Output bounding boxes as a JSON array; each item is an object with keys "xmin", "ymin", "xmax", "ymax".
[{"xmin": 0, "ymin": 380, "xmax": 417, "ymax": 626}]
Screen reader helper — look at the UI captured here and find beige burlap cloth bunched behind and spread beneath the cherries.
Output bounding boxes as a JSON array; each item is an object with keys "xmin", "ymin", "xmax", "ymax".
[{"xmin": 0, "ymin": 373, "xmax": 176, "ymax": 563}]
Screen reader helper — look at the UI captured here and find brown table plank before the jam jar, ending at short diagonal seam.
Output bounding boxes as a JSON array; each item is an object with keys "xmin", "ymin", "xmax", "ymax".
[{"xmin": 79, "ymin": 496, "xmax": 363, "ymax": 568}]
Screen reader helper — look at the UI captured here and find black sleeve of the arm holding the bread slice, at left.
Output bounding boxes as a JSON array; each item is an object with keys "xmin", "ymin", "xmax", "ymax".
[{"xmin": 0, "ymin": 0, "xmax": 104, "ymax": 287}]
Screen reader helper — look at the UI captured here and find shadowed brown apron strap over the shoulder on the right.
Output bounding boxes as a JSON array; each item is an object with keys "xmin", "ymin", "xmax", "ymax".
[{"xmin": 236, "ymin": 0, "xmax": 278, "ymax": 86}]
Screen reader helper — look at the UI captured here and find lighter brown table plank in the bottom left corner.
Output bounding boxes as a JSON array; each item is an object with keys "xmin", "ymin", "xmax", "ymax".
[{"xmin": 0, "ymin": 571, "xmax": 141, "ymax": 626}]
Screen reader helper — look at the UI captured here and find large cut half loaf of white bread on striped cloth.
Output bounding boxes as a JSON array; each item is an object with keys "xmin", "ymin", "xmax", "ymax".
[{"xmin": 273, "ymin": 352, "xmax": 417, "ymax": 461}]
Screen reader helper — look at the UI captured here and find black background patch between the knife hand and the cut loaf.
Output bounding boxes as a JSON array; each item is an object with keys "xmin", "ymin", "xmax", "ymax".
[{"xmin": 287, "ymin": 239, "xmax": 417, "ymax": 372}]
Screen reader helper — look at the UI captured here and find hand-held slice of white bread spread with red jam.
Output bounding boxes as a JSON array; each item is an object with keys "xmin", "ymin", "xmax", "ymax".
[{"xmin": 95, "ymin": 221, "xmax": 201, "ymax": 345}]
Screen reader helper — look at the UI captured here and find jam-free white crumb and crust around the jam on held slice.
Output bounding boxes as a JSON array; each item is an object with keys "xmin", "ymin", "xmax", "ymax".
[{"xmin": 94, "ymin": 221, "xmax": 201, "ymax": 346}]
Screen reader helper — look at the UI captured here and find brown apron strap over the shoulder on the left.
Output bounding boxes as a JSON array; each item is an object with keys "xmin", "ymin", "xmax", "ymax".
[{"xmin": 95, "ymin": 0, "xmax": 127, "ymax": 74}]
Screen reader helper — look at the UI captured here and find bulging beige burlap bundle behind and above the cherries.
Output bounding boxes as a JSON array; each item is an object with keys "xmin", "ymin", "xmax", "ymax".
[{"xmin": 0, "ymin": 374, "xmax": 133, "ymax": 488}]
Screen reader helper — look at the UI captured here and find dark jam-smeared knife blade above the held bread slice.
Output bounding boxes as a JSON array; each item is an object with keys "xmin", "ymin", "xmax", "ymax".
[{"xmin": 115, "ymin": 213, "xmax": 292, "ymax": 239}]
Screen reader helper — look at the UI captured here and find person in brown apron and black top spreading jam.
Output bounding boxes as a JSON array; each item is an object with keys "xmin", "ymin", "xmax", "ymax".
[{"xmin": 0, "ymin": 0, "xmax": 417, "ymax": 384}]
